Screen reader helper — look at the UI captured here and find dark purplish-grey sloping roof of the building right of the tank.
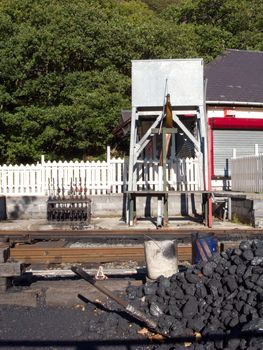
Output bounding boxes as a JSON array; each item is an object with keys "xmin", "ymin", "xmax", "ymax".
[{"xmin": 205, "ymin": 50, "xmax": 263, "ymax": 103}]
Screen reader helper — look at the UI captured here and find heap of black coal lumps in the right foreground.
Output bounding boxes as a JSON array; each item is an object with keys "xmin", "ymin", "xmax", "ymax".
[{"xmin": 127, "ymin": 240, "xmax": 263, "ymax": 350}]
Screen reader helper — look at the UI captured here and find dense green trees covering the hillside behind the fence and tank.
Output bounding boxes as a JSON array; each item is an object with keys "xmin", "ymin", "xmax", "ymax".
[{"xmin": 0, "ymin": 0, "xmax": 263, "ymax": 163}]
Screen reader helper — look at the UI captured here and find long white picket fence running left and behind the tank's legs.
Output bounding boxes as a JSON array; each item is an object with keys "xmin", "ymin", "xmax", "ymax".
[{"xmin": 0, "ymin": 157, "xmax": 200, "ymax": 196}]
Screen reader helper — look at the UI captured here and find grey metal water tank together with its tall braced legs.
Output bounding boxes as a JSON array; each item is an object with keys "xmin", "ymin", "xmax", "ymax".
[{"xmin": 128, "ymin": 59, "xmax": 208, "ymax": 224}]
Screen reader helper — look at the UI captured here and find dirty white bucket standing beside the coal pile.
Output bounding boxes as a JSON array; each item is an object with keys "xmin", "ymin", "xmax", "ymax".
[{"xmin": 144, "ymin": 240, "xmax": 178, "ymax": 280}]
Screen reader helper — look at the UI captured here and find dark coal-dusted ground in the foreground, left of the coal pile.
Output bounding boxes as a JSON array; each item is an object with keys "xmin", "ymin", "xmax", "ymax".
[{"xmin": 0, "ymin": 302, "xmax": 176, "ymax": 350}]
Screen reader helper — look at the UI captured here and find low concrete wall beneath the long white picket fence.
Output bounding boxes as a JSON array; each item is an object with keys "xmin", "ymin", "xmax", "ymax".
[{"xmin": 6, "ymin": 193, "xmax": 204, "ymax": 219}]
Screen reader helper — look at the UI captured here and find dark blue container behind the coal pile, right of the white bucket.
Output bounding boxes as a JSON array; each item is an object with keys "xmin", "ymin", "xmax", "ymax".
[{"xmin": 192, "ymin": 233, "xmax": 218, "ymax": 264}]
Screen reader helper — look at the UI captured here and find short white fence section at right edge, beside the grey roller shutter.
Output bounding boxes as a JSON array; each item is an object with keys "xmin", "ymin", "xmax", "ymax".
[{"xmin": 231, "ymin": 154, "xmax": 263, "ymax": 192}]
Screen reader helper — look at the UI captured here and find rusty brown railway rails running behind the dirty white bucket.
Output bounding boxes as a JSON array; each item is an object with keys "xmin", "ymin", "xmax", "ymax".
[{"xmin": 0, "ymin": 228, "xmax": 263, "ymax": 264}]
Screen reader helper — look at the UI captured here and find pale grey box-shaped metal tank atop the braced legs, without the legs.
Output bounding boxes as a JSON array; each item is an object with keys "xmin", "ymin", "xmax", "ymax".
[{"xmin": 132, "ymin": 59, "xmax": 204, "ymax": 108}]
